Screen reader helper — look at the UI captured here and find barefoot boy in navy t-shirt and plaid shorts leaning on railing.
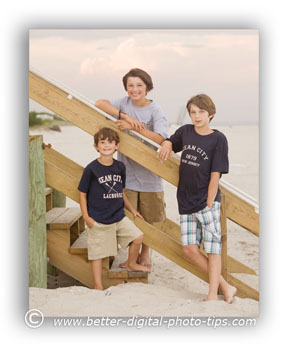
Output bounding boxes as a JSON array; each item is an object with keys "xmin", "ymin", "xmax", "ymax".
[{"xmin": 159, "ymin": 94, "xmax": 236, "ymax": 303}]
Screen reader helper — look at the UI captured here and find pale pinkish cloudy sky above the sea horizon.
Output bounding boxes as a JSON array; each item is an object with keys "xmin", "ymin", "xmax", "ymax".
[{"xmin": 29, "ymin": 29, "xmax": 259, "ymax": 124}]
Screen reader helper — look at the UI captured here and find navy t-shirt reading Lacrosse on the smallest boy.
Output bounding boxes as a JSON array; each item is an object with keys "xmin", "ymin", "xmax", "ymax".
[{"xmin": 78, "ymin": 160, "xmax": 126, "ymax": 224}]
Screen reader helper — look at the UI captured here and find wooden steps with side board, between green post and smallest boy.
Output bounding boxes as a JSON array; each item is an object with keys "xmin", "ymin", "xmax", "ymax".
[{"xmin": 46, "ymin": 188, "xmax": 148, "ymax": 288}]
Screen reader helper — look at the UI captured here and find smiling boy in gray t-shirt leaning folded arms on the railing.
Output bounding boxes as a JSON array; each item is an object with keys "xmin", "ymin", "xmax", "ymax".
[{"xmin": 95, "ymin": 68, "xmax": 168, "ymax": 267}]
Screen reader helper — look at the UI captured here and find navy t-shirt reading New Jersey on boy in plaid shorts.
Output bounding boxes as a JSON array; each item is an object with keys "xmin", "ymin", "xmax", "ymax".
[{"xmin": 167, "ymin": 124, "xmax": 229, "ymax": 215}]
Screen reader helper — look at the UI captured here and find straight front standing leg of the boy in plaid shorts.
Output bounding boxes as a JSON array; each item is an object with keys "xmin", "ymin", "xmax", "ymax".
[{"xmin": 206, "ymin": 254, "xmax": 221, "ymax": 300}]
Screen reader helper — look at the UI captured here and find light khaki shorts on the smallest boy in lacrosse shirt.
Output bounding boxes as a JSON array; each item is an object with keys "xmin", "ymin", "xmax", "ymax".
[{"xmin": 88, "ymin": 216, "xmax": 143, "ymax": 260}]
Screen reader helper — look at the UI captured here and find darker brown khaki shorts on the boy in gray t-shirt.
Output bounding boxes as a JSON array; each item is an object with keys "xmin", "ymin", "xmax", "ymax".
[{"xmin": 124, "ymin": 189, "xmax": 166, "ymax": 223}]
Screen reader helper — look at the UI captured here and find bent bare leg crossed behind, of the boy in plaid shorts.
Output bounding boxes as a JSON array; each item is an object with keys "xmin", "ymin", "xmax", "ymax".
[{"xmin": 183, "ymin": 245, "xmax": 237, "ymax": 304}]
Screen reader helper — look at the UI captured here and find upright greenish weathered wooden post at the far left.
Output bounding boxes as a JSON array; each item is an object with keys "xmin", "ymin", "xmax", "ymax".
[{"xmin": 29, "ymin": 136, "xmax": 47, "ymax": 288}]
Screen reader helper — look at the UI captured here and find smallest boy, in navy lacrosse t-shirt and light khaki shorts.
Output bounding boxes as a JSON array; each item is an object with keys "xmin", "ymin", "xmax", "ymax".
[{"xmin": 78, "ymin": 128, "xmax": 149, "ymax": 289}]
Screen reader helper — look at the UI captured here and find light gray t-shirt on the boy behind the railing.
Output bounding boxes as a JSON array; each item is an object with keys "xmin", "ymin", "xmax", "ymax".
[{"xmin": 110, "ymin": 96, "xmax": 168, "ymax": 192}]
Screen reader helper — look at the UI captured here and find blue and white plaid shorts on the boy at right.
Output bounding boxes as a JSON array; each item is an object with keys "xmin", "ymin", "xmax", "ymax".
[{"xmin": 180, "ymin": 202, "xmax": 221, "ymax": 255}]
